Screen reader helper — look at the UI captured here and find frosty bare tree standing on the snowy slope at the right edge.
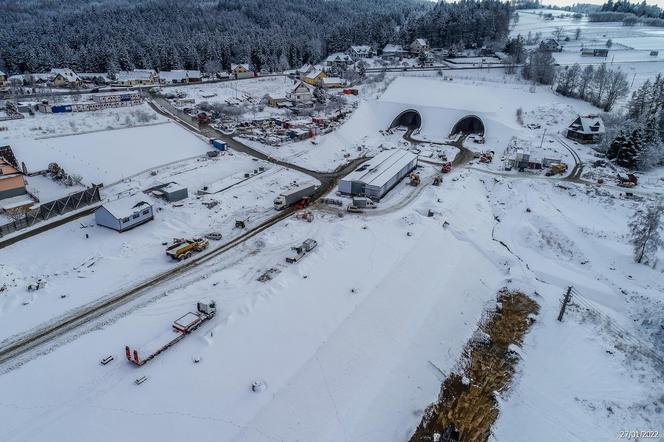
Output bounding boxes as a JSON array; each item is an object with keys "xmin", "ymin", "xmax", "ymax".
[{"xmin": 629, "ymin": 200, "xmax": 664, "ymax": 266}]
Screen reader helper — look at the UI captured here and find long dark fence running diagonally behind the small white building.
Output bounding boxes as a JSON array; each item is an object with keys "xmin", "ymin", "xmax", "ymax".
[{"xmin": 0, "ymin": 186, "xmax": 101, "ymax": 238}]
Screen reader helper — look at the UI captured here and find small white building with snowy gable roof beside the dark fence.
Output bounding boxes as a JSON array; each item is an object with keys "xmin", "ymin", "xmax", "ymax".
[{"xmin": 95, "ymin": 198, "xmax": 154, "ymax": 232}]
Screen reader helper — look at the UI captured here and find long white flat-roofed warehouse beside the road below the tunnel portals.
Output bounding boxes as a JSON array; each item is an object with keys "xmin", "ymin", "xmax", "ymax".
[{"xmin": 339, "ymin": 149, "xmax": 417, "ymax": 199}]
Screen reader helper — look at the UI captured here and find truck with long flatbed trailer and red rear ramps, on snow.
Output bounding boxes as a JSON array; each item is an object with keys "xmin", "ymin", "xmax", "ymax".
[{"xmin": 125, "ymin": 301, "xmax": 216, "ymax": 367}]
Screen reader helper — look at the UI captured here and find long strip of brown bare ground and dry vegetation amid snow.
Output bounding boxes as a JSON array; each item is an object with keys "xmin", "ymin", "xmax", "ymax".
[{"xmin": 410, "ymin": 291, "xmax": 539, "ymax": 442}]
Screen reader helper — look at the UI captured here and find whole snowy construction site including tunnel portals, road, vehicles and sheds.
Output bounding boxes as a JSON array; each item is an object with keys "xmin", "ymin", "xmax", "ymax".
[{"xmin": 0, "ymin": 57, "xmax": 664, "ymax": 442}]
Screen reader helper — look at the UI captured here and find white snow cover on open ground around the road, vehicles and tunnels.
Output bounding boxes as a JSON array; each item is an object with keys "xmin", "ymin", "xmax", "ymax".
[{"xmin": 0, "ymin": 32, "xmax": 664, "ymax": 442}]
